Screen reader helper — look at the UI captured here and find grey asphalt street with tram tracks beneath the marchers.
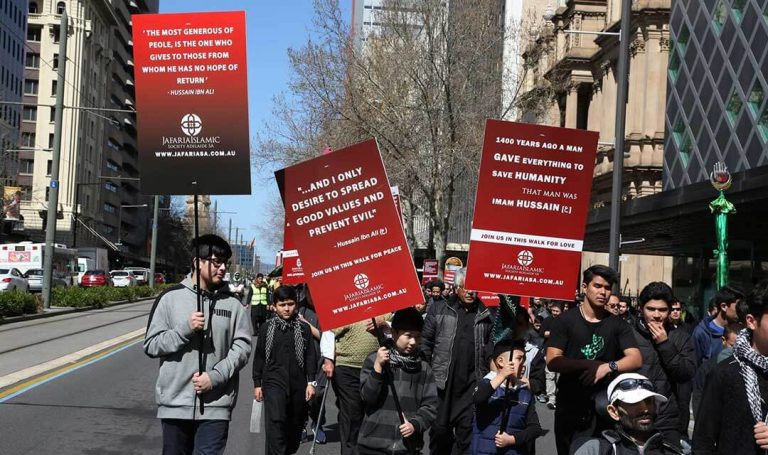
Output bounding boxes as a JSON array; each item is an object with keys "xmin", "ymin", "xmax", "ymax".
[{"xmin": 0, "ymin": 303, "xmax": 554, "ymax": 455}]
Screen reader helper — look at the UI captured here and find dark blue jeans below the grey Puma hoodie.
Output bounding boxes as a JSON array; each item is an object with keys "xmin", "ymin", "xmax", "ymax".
[{"xmin": 161, "ymin": 419, "xmax": 229, "ymax": 455}]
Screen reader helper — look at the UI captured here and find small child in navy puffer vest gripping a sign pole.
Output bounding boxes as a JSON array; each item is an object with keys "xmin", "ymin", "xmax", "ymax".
[{"xmin": 470, "ymin": 340, "xmax": 543, "ymax": 455}]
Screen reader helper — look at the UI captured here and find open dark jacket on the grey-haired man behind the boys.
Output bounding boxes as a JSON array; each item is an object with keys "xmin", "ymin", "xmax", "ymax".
[{"xmin": 421, "ymin": 295, "xmax": 493, "ymax": 389}]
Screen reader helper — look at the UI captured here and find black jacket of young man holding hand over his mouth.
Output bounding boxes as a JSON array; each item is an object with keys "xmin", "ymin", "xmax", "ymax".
[{"xmin": 633, "ymin": 319, "xmax": 696, "ymax": 445}]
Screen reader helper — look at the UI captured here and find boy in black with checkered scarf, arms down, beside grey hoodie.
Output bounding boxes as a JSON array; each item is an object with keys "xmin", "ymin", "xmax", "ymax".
[{"xmin": 253, "ymin": 286, "xmax": 317, "ymax": 455}]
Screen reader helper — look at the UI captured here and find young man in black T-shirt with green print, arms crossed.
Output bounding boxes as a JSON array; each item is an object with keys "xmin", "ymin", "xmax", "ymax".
[{"xmin": 547, "ymin": 265, "xmax": 643, "ymax": 455}]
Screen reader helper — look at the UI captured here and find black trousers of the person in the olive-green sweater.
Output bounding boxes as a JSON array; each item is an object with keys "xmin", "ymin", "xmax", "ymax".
[{"xmin": 333, "ymin": 366, "xmax": 363, "ymax": 455}]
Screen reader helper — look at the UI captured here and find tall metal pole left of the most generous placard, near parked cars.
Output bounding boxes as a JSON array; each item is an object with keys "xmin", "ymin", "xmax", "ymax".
[{"xmin": 43, "ymin": 11, "xmax": 67, "ymax": 309}]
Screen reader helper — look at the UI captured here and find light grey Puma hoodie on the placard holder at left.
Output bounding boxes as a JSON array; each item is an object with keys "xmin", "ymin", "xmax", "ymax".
[{"xmin": 144, "ymin": 276, "xmax": 251, "ymax": 420}]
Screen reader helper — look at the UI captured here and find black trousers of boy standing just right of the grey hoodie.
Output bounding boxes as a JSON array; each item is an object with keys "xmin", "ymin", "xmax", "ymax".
[{"xmin": 263, "ymin": 386, "xmax": 308, "ymax": 455}]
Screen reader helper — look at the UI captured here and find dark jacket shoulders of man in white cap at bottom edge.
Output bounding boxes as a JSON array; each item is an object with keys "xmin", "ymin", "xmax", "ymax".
[{"xmin": 571, "ymin": 430, "xmax": 683, "ymax": 455}]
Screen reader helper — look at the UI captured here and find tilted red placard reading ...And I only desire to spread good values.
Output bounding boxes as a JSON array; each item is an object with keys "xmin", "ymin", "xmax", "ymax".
[{"xmin": 275, "ymin": 139, "xmax": 424, "ymax": 329}]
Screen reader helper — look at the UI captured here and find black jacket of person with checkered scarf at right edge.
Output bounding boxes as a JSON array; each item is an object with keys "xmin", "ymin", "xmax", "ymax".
[{"xmin": 692, "ymin": 356, "xmax": 768, "ymax": 455}]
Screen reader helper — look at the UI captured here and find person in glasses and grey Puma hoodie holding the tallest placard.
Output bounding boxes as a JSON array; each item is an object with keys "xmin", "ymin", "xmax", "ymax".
[{"xmin": 144, "ymin": 234, "xmax": 251, "ymax": 454}]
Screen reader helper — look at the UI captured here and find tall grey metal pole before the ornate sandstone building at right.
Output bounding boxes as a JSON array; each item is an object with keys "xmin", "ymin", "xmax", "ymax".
[{"xmin": 608, "ymin": 0, "xmax": 632, "ymax": 278}]
